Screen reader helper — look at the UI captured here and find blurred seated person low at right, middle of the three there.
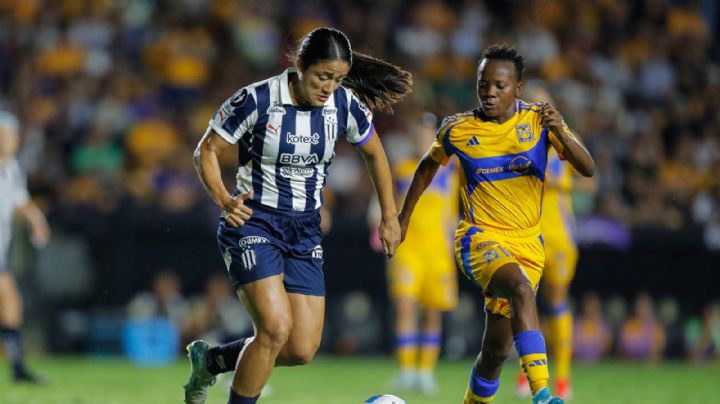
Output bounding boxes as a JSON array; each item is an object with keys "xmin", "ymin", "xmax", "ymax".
[{"xmin": 618, "ymin": 293, "xmax": 665, "ymax": 361}]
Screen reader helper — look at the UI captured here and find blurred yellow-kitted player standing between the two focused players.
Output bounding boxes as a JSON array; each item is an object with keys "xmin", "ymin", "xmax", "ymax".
[{"xmin": 388, "ymin": 113, "xmax": 458, "ymax": 395}]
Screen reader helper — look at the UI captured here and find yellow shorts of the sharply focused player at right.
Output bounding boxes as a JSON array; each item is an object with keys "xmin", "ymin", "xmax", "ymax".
[{"xmin": 455, "ymin": 220, "xmax": 545, "ymax": 318}]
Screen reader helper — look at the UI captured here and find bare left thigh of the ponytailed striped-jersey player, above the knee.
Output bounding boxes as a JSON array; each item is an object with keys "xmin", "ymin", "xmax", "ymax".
[{"xmin": 237, "ymin": 274, "xmax": 293, "ymax": 342}]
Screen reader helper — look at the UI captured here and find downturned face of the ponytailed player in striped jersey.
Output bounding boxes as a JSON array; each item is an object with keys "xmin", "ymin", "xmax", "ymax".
[{"xmin": 300, "ymin": 59, "xmax": 350, "ymax": 107}]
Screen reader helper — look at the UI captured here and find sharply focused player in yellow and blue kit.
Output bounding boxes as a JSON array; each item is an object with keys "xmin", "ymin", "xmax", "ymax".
[{"xmin": 399, "ymin": 45, "xmax": 595, "ymax": 404}]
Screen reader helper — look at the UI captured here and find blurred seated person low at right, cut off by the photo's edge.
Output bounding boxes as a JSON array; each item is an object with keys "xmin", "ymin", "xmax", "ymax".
[{"xmin": 685, "ymin": 303, "xmax": 720, "ymax": 363}]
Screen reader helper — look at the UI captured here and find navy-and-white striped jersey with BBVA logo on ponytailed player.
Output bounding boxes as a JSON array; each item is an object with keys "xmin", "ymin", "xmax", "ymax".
[{"xmin": 208, "ymin": 68, "xmax": 375, "ymax": 211}]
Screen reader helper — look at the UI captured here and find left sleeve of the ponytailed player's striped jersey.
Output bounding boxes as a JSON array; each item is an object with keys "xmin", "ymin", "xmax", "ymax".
[{"xmin": 210, "ymin": 87, "xmax": 258, "ymax": 144}]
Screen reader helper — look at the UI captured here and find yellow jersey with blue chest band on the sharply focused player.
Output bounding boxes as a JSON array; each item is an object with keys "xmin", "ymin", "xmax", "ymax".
[{"xmin": 429, "ymin": 100, "xmax": 574, "ymax": 230}]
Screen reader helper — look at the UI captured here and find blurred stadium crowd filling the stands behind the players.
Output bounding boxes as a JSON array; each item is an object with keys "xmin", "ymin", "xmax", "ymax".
[{"xmin": 0, "ymin": 0, "xmax": 720, "ymax": 360}]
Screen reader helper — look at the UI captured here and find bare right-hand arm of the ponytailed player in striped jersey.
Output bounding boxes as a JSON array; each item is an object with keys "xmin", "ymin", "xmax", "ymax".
[{"xmin": 357, "ymin": 136, "xmax": 400, "ymax": 257}]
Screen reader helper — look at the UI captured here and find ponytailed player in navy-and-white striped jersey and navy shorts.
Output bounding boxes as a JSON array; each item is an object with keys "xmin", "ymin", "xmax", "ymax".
[{"xmin": 185, "ymin": 28, "xmax": 412, "ymax": 404}]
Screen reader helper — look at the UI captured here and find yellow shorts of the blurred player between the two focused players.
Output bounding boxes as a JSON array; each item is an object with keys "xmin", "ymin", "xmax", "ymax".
[{"xmin": 388, "ymin": 242, "xmax": 458, "ymax": 311}]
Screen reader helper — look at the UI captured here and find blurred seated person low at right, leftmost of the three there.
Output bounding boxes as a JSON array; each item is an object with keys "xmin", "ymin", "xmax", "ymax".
[{"xmin": 573, "ymin": 292, "xmax": 612, "ymax": 362}]
